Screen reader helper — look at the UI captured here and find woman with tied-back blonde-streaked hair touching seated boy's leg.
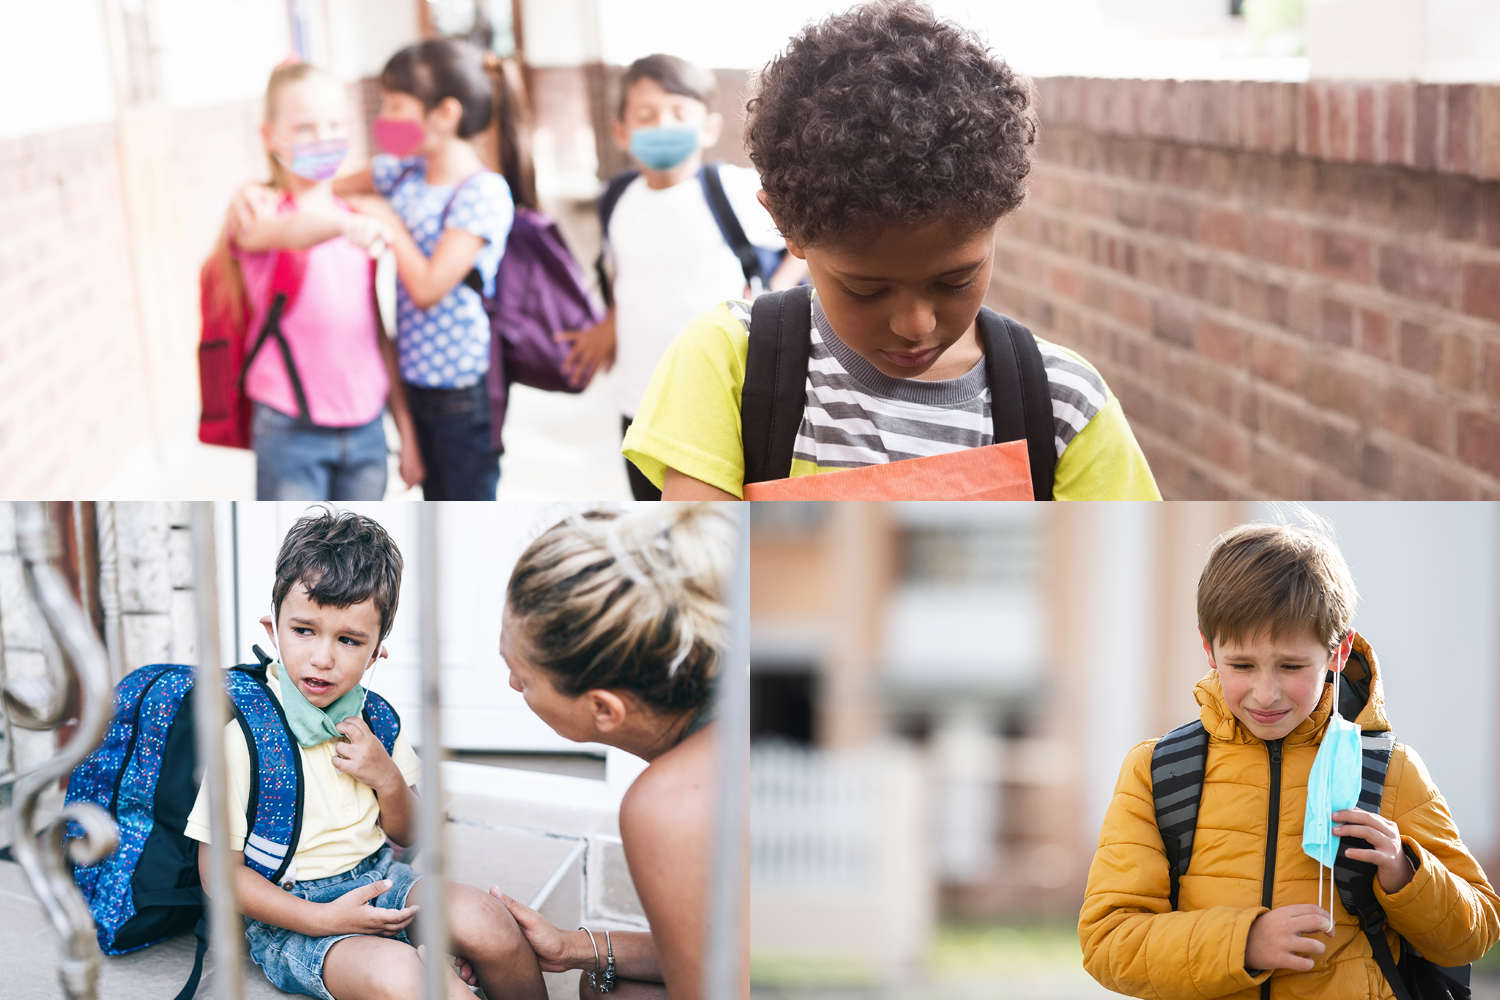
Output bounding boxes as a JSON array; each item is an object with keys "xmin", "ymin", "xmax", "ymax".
[{"xmin": 465, "ymin": 504, "xmax": 735, "ymax": 1000}]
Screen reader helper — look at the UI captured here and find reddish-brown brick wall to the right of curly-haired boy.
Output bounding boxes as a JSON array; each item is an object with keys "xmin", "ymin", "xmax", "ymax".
[{"xmin": 992, "ymin": 79, "xmax": 1500, "ymax": 499}]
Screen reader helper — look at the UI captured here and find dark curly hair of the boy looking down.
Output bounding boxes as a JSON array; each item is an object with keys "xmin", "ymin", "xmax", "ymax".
[{"xmin": 746, "ymin": 0, "xmax": 1037, "ymax": 244}]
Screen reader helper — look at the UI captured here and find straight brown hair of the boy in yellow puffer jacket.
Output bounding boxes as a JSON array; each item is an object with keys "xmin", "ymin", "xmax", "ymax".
[{"xmin": 1199, "ymin": 523, "xmax": 1359, "ymax": 652}]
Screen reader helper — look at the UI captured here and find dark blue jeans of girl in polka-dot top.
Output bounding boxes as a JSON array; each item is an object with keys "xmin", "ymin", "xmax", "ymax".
[{"xmin": 407, "ymin": 379, "xmax": 500, "ymax": 499}]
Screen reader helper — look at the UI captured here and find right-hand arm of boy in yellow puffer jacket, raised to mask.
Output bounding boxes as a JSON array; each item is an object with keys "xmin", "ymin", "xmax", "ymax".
[{"xmin": 1374, "ymin": 745, "xmax": 1500, "ymax": 966}]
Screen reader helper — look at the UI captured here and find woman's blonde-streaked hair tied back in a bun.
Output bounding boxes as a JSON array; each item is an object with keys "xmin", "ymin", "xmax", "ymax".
[{"xmin": 506, "ymin": 504, "xmax": 735, "ymax": 714}]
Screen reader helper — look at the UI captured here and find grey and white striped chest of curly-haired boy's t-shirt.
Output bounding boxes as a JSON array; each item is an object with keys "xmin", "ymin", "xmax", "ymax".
[{"xmin": 726, "ymin": 297, "xmax": 1106, "ymax": 469}]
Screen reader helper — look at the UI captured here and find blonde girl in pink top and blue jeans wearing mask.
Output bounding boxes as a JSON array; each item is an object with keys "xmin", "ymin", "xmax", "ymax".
[{"xmin": 216, "ymin": 63, "xmax": 423, "ymax": 501}]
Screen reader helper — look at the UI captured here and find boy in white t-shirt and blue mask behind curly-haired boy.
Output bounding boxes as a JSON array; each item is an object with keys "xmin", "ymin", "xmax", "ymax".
[{"xmin": 558, "ymin": 54, "xmax": 807, "ymax": 499}]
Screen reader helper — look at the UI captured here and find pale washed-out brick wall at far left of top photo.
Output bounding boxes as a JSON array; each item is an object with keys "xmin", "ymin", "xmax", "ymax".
[{"xmin": 0, "ymin": 124, "xmax": 152, "ymax": 496}]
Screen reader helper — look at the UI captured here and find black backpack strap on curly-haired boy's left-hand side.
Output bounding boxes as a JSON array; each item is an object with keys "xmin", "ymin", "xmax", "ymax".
[{"xmin": 740, "ymin": 285, "xmax": 813, "ymax": 483}]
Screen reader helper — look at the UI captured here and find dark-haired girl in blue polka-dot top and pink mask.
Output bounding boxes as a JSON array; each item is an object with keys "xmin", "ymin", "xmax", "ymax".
[{"xmin": 335, "ymin": 39, "xmax": 515, "ymax": 499}]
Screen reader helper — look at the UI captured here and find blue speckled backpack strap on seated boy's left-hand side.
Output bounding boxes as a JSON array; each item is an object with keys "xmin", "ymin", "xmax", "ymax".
[{"xmin": 224, "ymin": 664, "xmax": 305, "ymax": 882}]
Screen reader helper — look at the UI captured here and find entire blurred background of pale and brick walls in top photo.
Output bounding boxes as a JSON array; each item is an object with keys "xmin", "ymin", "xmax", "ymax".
[{"xmin": 0, "ymin": 0, "xmax": 1500, "ymax": 499}]
